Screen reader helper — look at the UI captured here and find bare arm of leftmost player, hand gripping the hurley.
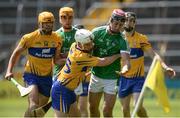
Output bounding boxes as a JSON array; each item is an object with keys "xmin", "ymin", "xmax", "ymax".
[{"xmin": 5, "ymin": 45, "xmax": 26, "ymax": 80}]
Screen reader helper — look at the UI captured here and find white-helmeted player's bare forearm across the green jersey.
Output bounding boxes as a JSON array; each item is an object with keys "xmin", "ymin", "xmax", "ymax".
[{"xmin": 96, "ymin": 54, "xmax": 121, "ymax": 66}]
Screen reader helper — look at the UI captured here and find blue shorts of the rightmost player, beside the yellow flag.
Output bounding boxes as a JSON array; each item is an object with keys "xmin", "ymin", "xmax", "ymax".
[{"xmin": 118, "ymin": 77, "xmax": 145, "ymax": 98}]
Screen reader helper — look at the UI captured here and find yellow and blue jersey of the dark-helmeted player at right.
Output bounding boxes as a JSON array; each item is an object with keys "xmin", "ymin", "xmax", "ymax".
[{"xmin": 123, "ymin": 32, "xmax": 151, "ymax": 78}]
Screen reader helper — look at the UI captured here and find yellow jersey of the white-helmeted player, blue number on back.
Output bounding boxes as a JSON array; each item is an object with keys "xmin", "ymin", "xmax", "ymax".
[{"xmin": 58, "ymin": 43, "xmax": 98, "ymax": 90}]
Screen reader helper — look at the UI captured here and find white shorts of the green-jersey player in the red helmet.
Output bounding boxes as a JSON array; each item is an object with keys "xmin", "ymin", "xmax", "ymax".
[{"xmin": 89, "ymin": 74, "xmax": 117, "ymax": 94}]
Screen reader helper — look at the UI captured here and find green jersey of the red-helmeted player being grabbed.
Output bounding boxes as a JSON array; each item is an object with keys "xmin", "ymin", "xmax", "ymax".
[{"xmin": 92, "ymin": 26, "xmax": 129, "ymax": 79}]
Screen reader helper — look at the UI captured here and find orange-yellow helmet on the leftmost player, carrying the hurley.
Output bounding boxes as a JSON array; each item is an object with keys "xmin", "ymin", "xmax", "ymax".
[{"xmin": 38, "ymin": 11, "xmax": 55, "ymax": 23}]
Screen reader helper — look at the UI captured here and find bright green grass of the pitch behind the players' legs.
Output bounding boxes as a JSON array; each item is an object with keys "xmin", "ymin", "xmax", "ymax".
[{"xmin": 0, "ymin": 97, "xmax": 180, "ymax": 117}]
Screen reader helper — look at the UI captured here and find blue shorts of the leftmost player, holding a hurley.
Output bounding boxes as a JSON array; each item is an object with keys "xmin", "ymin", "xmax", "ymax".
[{"xmin": 23, "ymin": 73, "xmax": 52, "ymax": 97}]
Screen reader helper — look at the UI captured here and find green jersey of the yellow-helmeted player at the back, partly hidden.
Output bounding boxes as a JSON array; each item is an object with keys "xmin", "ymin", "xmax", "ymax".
[{"xmin": 53, "ymin": 27, "xmax": 78, "ymax": 75}]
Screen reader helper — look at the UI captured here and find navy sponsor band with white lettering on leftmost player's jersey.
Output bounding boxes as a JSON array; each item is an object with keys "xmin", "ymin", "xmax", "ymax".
[{"xmin": 28, "ymin": 47, "xmax": 56, "ymax": 58}]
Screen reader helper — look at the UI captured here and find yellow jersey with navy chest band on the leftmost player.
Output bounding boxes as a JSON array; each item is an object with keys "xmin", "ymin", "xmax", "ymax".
[{"xmin": 19, "ymin": 30, "xmax": 62, "ymax": 76}]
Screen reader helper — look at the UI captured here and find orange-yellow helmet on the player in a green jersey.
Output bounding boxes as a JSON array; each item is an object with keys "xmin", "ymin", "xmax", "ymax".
[{"xmin": 59, "ymin": 7, "xmax": 74, "ymax": 16}]
